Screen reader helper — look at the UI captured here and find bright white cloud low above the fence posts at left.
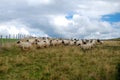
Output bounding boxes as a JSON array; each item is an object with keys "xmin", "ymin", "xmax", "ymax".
[{"xmin": 0, "ymin": 21, "xmax": 30, "ymax": 35}]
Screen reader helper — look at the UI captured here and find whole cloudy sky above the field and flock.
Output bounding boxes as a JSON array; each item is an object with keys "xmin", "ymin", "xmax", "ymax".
[{"xmin": 0, "ymin": 0, "xmax": 120, "ymax": 39}]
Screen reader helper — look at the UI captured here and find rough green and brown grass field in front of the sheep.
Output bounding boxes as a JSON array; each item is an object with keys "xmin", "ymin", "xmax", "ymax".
[{"xmin": 0, "ymin": 41, "xmax": 120, "ymax": 80}]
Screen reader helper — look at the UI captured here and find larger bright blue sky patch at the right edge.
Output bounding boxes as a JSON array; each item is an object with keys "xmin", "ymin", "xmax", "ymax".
[{"xmin": 102, "ymin": 13, "xmax": 120, "ymax": 22}]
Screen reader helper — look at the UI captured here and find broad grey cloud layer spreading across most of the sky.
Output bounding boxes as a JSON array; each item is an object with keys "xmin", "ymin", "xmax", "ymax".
[{"xmin": 0, "ymin": 0, "xmax": 120, "ymax": 38}]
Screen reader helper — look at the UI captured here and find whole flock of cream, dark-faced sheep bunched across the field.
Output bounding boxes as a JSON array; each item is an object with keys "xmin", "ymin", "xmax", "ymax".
[{"xmin": 17, "ymin": 37, "xmax": 103, "ymax": 50}]
